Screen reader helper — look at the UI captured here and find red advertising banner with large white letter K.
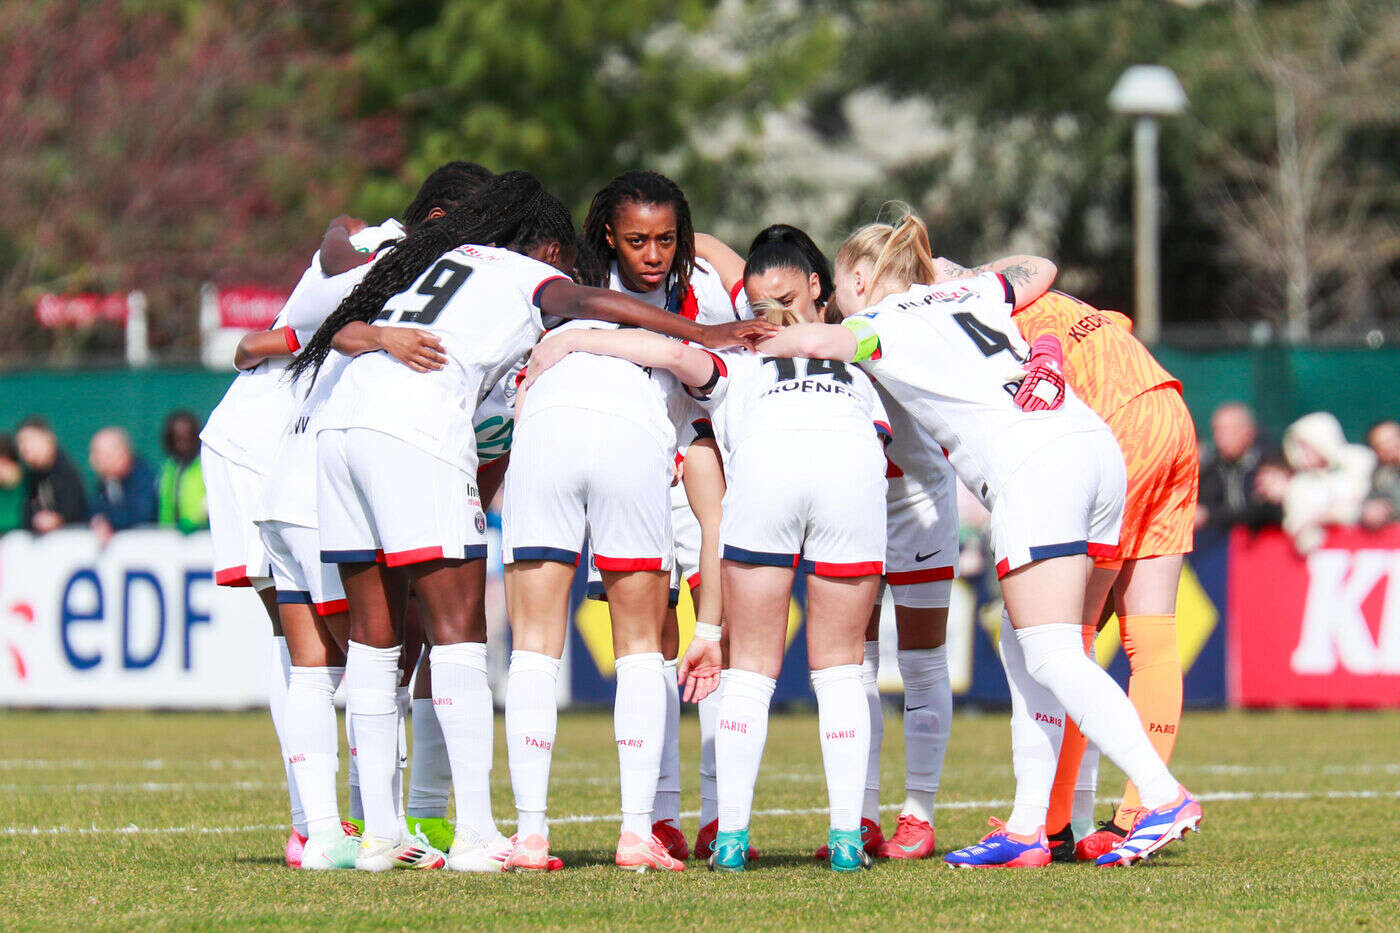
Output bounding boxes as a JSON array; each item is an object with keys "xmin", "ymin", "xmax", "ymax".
[{"xmin": 1228, "ymin": 525, "xmax": 1400, "ymax": 706}]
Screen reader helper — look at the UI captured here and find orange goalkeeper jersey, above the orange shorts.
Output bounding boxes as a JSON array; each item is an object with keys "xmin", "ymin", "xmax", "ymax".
[{"xmin": 1015, "ymin": 291, "xmax": 1182, "ymax": 419}]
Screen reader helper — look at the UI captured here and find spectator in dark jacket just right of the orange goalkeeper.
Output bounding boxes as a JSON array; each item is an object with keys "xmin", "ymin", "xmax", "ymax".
[{"xmin": 1196, "ymin": 402, "xmax": 1282, "ymax": 535}]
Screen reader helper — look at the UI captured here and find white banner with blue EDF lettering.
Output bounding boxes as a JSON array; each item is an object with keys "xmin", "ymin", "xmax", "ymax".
[{"xmin": 0, "ymin": 530, "xmax": 272, "ymax": 700}]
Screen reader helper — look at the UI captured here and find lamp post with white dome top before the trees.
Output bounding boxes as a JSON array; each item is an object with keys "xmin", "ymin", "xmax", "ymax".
[{"xmin": 1109, "ymin": 64, "xmax": 1186, "ymax": 345}]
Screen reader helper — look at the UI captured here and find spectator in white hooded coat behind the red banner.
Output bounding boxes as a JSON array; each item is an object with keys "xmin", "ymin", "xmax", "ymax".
[{"xmin": 1282, "ymin": 412, "xmax": 1376, "ymax": 553}]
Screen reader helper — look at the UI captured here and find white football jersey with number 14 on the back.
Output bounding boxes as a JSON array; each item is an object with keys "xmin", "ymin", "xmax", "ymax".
[{"xmin": 701, "ymin": 350, "xmax": 889, "ymax": 469}]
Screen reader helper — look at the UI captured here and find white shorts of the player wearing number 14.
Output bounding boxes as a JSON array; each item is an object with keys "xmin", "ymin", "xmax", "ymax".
[{"xmin": 720, "ymin": 430, "xmax": 886, "ymax": 577}]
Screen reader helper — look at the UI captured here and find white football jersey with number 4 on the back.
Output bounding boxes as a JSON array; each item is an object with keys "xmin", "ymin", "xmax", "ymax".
[{"xmin": 846, "ymin": 273, "xmax": 1103, "ymax": 509}]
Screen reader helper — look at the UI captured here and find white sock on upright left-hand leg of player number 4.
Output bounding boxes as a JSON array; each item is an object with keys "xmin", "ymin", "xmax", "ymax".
[{"xmin": 1001, "ymin": 612, "xmax": 1064, "ymax": 835}]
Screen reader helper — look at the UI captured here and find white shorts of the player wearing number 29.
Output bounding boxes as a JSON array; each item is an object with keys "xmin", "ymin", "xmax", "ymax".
[{"xmin": 316, "ymin": 427, "xmax": 486, "ymax": 567}]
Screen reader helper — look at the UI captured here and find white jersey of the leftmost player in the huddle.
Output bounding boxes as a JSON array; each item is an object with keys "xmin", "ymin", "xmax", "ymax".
[{"xmin": 200, "ymin": 219, "xmax": 403, "ymax": 474}]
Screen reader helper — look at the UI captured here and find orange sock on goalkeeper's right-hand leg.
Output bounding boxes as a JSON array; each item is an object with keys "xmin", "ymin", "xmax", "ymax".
[{"xmin": 1114, "ymin": 615, "xmax": 1182, "ymax": 828}]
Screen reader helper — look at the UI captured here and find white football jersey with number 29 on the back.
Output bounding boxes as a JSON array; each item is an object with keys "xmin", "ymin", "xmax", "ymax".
[{"xmin": 318, "ymin": 244, "xmax": 568, "ymax": 475}]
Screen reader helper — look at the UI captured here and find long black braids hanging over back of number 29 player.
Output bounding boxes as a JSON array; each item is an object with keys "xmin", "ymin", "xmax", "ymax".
[{"xmin": 287, "ymin": 171, "xmax": 574, "ymax": 380}]
